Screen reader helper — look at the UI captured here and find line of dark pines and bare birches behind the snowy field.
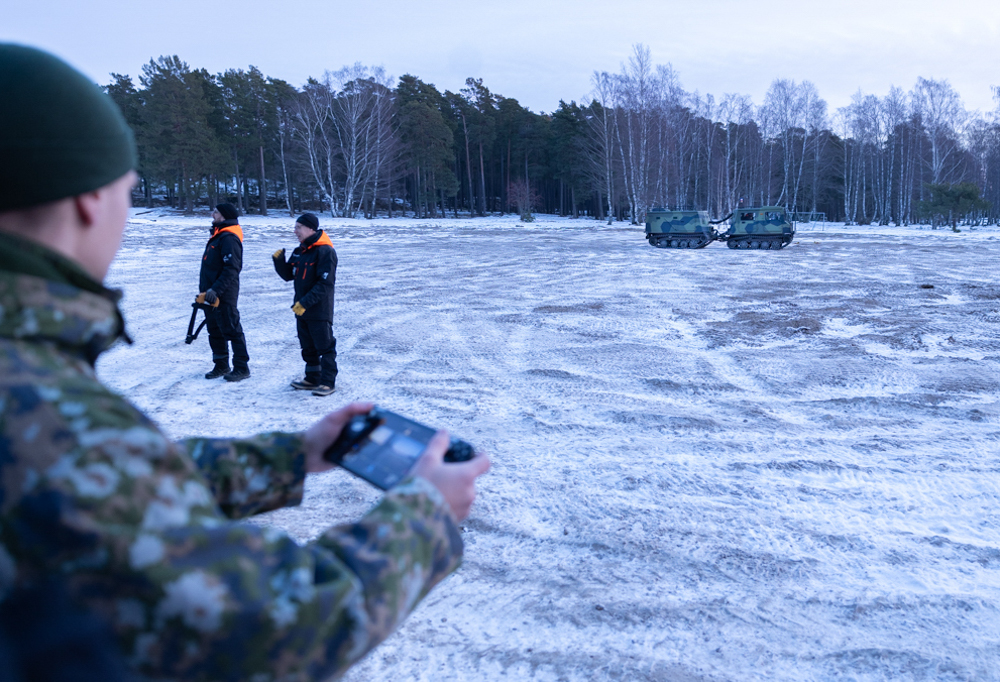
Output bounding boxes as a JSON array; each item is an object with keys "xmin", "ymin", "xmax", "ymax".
[{"xmin": 105, "ymin": 45, "xmax": 1000, "ymax": 226}]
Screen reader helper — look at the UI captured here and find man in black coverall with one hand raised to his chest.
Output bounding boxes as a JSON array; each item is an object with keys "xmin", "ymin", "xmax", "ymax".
[{"xmin": 273, "ymin": 213, "xmax": 337, "ymax": 396}]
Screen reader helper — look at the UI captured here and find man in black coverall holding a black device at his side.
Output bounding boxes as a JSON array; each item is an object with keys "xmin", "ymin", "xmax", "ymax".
[{"xmin": 199, "ymin": 204, "xmax": 250, "ymax": 381}]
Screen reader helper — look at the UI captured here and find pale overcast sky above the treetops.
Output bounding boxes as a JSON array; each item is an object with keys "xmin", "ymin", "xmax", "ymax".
[{"xmin": 0, "ymin": 0, "xmax": 1000, "ymax": 111}]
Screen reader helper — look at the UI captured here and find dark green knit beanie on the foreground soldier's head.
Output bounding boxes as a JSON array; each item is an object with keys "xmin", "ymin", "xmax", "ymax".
[{"xmin": 0, "ymin": 43, "xmax": 138, "ymax": 211}]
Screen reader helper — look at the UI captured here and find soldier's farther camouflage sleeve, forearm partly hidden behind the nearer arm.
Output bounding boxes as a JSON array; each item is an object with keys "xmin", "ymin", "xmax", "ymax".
[{"xmin": 179, "ymin": 433, "xmax": 306, "ymax": 519}]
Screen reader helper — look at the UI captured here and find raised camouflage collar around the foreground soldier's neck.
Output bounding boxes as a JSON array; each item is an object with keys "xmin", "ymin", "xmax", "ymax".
[{"xmin": 0, "ymin": 235, "xmax": 131, "ymax": 365}]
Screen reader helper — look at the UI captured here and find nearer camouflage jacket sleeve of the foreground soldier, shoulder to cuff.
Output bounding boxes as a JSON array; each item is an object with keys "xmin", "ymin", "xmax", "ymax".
[{"xmin": 2, "ymin": 382, "xmax": 462, "ymax": 682}]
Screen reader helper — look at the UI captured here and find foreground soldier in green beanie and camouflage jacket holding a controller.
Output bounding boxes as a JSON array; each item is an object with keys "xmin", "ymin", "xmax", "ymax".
[{"xmin": 0, "ymin": 44, "xmax": 489, "ymax": 682}]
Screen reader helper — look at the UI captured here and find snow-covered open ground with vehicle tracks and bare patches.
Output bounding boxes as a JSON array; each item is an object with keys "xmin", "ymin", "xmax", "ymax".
[{"xmin": 98, "ymin": 209, "xmax": 1000, "ymax": 682}]
